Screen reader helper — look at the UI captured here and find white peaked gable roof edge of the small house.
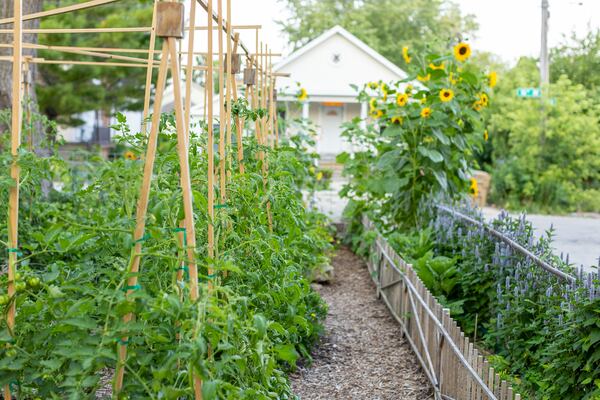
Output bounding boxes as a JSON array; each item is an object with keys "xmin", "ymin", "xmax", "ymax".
[{"xmin": 274, "ymin": 25, "xmax": 408, "ymax": 79}]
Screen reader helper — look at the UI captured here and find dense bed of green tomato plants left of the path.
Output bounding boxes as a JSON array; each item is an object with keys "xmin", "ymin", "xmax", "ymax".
[{"xmin": 0, "ymin": 109, "xmax": 331, "ymax": 399}]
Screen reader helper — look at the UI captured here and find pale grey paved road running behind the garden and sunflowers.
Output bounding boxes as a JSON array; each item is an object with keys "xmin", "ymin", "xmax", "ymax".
[{"xmin": 315, "ymin": 173, "xmax": 600, "ymax": 268}]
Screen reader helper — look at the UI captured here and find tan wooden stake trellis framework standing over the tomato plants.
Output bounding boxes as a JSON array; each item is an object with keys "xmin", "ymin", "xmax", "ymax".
[{"xmin": 0, "ymin": 0, "xmax": 279, "ymax": 399}]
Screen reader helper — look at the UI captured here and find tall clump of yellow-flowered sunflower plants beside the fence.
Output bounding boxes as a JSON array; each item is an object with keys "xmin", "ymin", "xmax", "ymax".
[{"xmin": 338, "ymin": 43, "xmax": 489, "ymax": 227}]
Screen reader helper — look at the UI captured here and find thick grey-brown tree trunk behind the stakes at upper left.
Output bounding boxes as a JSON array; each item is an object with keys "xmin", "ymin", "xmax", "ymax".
[{"xmin": 0, "ymin": 0, "xmax": 43, "ymax": 109}]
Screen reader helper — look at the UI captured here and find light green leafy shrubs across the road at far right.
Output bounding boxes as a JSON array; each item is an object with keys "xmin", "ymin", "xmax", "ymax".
[{"xmin": 490, "ymin": 59, "xmax": 600, "ymax": 212}]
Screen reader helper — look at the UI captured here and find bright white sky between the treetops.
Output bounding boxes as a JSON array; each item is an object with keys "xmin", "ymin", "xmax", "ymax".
[{"xmin": 210, "ymin": 0, "xmax": 600, "ymax": 64}]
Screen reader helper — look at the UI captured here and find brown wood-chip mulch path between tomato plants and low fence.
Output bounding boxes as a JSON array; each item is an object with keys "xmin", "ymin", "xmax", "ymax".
[{"xmin": 291, "ymin": 247, "xmax": 433, "ymax": 400}]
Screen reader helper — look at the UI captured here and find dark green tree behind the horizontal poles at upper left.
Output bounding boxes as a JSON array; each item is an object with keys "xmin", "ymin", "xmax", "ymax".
[{"xmin": 37, "ymin": 0, "xmax": 153, "ymax": 125}]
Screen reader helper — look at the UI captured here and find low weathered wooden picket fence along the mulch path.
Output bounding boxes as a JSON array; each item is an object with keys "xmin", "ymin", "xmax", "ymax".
[{"xmin": 363, "ymin": 219, "xmax": 521, "ymax": 400}]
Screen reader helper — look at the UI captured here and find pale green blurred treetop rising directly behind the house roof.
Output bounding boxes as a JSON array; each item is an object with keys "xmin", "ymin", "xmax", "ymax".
[{"xmin": 278, "ymin": 0, "xmax": 477, "ymax": 66}]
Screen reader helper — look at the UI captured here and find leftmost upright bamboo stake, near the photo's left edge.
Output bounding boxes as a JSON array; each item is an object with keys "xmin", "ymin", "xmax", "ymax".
[{"xmin": 4, "ymin": 0, "xmax": 23, "ymax": 399}]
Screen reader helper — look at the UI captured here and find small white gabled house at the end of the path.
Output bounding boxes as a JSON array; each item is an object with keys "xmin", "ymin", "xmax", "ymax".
[{"xmin": 275, "ymin": 26, "xmax": 407, "ymax": 161}]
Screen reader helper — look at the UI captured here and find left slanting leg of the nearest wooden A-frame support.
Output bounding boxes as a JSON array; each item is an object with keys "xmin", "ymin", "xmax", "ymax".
[{"xmin": 114, "ymin": 41, "xmax": 169, "ymax": 393}]
